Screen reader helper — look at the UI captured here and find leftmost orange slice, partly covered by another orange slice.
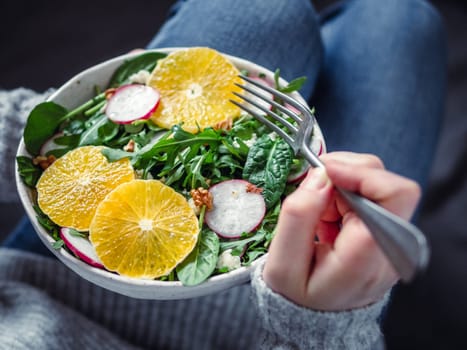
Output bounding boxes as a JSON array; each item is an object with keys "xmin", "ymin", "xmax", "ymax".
[{"xmin": 37, "ymin": 146, "xmax": 135, "ymax": 231}]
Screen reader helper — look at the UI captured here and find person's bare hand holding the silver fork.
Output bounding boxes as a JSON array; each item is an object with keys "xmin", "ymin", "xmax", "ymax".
[{"xmin": 263, "ymin": 152, "xmax": 420, "ymax": 311}]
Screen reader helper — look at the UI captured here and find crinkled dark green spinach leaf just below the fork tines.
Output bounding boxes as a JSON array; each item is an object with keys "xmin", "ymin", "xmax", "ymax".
[{"xmin": 243, "ymin": 135, "xmax": 293, "ymax": 209}]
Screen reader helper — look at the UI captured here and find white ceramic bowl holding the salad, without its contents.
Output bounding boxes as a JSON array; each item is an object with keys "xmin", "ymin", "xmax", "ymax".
[{"xmin": 16, "ymin": 48, "xmax": 324, "ymax": 300}]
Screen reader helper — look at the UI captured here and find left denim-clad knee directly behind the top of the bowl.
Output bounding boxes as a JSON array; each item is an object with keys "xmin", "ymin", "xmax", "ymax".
[{"xmin": 148, "ymin": 0, "xmax": 322, "ymax": 95}]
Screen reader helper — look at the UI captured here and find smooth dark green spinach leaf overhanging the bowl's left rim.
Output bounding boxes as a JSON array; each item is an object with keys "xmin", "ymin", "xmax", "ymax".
[{"xmin": 23, "ymin": 102, "xmax": 68, "ymax": 156}]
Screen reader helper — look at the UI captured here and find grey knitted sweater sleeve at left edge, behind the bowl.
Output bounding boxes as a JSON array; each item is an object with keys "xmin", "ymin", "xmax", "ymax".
[{"xmin": 0, "ymin": 88, "xmax": 52, "ymax": 203}]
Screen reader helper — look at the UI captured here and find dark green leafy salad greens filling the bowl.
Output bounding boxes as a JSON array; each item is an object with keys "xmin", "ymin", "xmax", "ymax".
[{"xmin": 17, "ymin": 52, "xmax": 314, "ymax": 285}]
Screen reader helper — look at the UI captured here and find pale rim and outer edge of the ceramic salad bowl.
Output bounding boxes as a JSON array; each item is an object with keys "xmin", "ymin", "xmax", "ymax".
[{"xmin": 15, "ymin": 47, "xmax": 326, "ymax": 300}]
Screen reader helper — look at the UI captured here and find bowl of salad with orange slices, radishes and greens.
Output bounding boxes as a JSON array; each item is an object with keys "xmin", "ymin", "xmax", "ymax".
[{"xmin": 16, "ymin": 47, "xmax": 325, "ymax": 299}]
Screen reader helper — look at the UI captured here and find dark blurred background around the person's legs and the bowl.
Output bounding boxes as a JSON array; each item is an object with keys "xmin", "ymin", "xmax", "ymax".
[{"xmin": 0, "ymin": 0, "xmax": 467, "ymax": 349}]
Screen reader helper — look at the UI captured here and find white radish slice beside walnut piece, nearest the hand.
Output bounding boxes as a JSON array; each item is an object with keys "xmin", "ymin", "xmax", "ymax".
[{"xmin": 205, "ymin": 179, "xmax": 266, "ymax": 238}]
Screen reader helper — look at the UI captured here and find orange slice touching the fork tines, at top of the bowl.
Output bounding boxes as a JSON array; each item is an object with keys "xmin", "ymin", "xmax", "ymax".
[{"xmin": 147, "ymin": 47, "xmax": 243, "ymax": 133}]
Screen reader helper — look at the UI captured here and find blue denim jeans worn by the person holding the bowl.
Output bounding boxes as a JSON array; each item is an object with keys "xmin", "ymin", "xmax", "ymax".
[{"xmin": 6, "ymin": 0, "xmax": 446, "ymax": 258}]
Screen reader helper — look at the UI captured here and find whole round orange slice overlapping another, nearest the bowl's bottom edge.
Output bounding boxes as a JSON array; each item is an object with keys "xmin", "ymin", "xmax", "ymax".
[{"xmin": 89, "ymin": 180, "xmax": 199, "ymax": 279}]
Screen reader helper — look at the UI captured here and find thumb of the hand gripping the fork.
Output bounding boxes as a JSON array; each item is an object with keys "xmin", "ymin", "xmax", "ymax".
[{"xmin": 263, "ymin": 168, "xmax": 332, "ymax": 300}]
